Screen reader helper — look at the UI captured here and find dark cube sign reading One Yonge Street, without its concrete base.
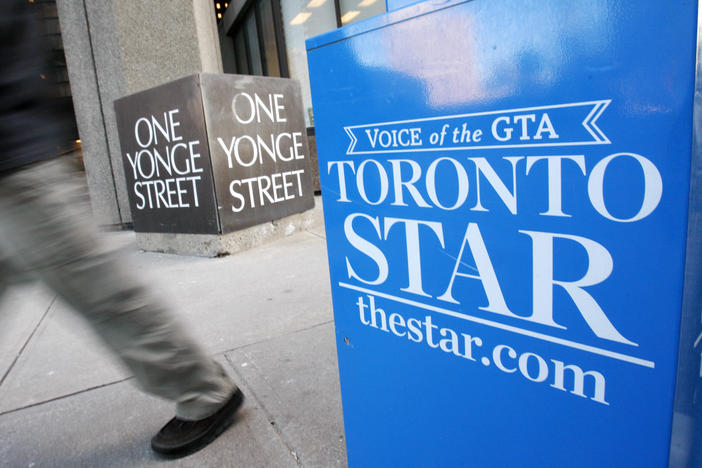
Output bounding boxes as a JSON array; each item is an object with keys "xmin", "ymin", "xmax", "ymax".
[{"xmin": 115, "ymin": 73, "xmax": 314, "ymax": 234}]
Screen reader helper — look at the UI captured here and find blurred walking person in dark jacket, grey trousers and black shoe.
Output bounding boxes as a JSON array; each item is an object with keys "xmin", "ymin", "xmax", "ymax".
[{"xmin": 0, "ymin": 0, "xmax": 243, "ymax": 455}]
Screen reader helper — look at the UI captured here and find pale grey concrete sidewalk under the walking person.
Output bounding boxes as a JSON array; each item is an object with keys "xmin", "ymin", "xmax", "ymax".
[{"xmin": 0, "ymin": 198, "xmax": 346, "ymax": 468}]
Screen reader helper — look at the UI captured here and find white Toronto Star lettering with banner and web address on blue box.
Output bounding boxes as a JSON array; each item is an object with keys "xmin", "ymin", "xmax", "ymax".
[{"xmin": 326, "ymin": 100, "xmax": 663, "ymax": 405}]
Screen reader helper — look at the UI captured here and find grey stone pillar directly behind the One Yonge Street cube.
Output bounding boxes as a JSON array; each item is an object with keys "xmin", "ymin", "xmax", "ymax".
[{"xmin": 57, "ymin": 0, "xmax": 222, "ymax": 226}]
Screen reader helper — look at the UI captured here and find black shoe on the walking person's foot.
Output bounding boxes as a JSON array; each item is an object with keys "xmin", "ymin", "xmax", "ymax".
[{"xmin": 151, "ymin": 388, "xmax": 244, "ymax": 457}]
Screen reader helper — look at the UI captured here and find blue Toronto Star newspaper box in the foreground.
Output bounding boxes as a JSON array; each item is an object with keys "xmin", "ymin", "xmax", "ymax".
[{"xmin": 307, "ymin": 0, "xmax": 702, "ymax": 467}]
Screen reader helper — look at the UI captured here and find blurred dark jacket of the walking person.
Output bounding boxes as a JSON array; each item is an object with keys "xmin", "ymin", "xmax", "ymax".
[{"xmin": 0, "ymin": 0, "xmax": 66, "ymax": 173}]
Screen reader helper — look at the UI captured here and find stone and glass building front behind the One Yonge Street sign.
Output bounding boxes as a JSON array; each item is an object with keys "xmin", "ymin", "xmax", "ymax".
[{"xmin": 51, "ymin": 0, "xmax": 386, "ymax": 227}]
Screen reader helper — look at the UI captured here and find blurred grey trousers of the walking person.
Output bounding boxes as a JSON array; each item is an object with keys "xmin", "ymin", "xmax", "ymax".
[{"xmin": 0, "ymin": 160, "xmax": 236, "ymax": 420}]
